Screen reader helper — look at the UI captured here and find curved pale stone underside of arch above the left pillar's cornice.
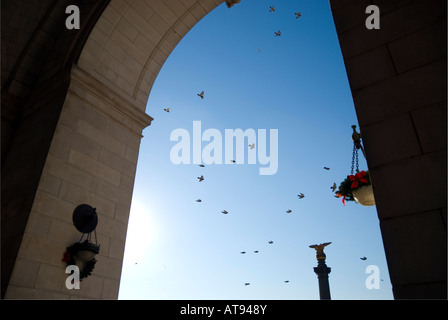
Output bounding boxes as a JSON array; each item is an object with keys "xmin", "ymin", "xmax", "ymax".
[{"xmin": 78, "ymin": 0, "xmax": 223, "ymax": 111}]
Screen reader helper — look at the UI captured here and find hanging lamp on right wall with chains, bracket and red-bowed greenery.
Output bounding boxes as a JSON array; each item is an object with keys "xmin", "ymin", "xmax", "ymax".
[{"xmin": 335, "ymin": 125, "xmax": 375, "ymax": 206}]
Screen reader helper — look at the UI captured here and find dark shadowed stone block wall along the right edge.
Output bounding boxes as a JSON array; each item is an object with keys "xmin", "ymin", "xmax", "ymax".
[{"xmin": 331, "ymin": 0, "xmax": 447, "ymax": 299}]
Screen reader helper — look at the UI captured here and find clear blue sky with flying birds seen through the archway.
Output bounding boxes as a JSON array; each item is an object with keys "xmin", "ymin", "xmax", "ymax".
[{"xmin": 119, "ymin": 0, "xmax": 393, "ymax": 300}]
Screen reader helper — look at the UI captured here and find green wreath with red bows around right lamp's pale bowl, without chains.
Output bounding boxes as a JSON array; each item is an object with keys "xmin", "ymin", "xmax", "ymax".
[{"xmin": 336, "ymin": 170, "xmax": 375, "ymax": 206}]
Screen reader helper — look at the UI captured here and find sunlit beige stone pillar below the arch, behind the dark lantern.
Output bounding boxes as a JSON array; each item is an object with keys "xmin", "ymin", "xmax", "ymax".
[{"xmin": 5, "ymin": 65, "xmax": 152, "ymax": 299}]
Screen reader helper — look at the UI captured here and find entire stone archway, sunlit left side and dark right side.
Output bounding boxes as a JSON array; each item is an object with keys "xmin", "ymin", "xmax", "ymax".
[{"xmin": 2, "ymin": 0, "xmax": 446, "ymax": 299}]
